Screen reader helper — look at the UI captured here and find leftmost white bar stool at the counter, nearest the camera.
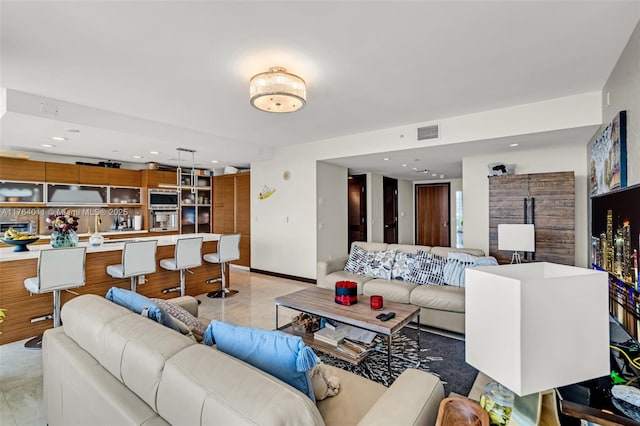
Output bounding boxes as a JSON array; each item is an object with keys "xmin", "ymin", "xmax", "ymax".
[{"xmin": 24, "ymin": 247, "xmax": 87, "ymax": 349}]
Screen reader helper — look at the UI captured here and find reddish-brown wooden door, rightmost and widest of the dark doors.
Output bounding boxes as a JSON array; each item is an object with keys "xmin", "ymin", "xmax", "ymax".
[{"xmin": 416, "ymin": 183, "xmax": 451, "ymax": 247}]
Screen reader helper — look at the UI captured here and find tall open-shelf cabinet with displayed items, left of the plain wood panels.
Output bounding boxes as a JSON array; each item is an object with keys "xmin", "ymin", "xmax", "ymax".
[{"xmin": 180, "ymin": 171, "xmax": 211, "ymax": 234}]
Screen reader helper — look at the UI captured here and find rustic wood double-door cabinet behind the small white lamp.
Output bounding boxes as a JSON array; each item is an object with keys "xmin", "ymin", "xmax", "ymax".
[{"xmin": 489, "ymin": 172, "xmax": 575, "ymax": 265}]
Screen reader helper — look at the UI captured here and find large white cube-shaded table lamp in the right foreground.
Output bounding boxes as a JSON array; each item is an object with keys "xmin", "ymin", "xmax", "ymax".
[{"xmin": 465, "ymin": 262, "xmax": 610, "ymax": 425}]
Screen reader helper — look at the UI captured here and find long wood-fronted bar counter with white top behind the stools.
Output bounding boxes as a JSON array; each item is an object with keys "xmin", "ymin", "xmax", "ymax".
[{"xmin": 0, "ymin": 234, "xmax": 225, "ymax": 344}]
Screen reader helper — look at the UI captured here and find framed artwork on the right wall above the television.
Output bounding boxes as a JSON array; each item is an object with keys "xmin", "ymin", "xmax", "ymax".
[{"xmin": 590, "ymin": 111, "xmax": 627, "ymax": 196}]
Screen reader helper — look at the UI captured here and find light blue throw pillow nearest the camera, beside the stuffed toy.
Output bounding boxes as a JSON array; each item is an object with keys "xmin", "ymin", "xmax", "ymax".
[{"xmin": 204, "ymin": 320, "xmax": 318, "ymax": 402}]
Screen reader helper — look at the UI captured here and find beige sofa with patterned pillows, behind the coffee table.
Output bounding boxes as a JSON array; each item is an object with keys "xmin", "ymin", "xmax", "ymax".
[{"xmin": 317, "ymin": 241, "xmax": 484, "ymax": 333}]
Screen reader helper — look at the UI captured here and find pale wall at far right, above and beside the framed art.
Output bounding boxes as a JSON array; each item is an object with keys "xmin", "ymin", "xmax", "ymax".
[{"xmin": 592, "ymin": 23, "xmax": 640, "ymax": 186}]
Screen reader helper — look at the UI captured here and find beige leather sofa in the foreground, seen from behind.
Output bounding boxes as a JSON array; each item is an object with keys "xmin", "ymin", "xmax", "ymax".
[{"xmin": 42, "ymin": 295, "xmax": 444, "ymax": 426}]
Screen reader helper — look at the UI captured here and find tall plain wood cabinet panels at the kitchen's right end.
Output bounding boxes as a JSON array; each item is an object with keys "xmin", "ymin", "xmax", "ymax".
[{"xmin": 213, "ymin": 173, "xmax": 251, "ymax": 267}]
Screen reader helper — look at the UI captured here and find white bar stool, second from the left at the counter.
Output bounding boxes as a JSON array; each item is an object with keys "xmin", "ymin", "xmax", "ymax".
[{"xmin": 107, "ymin": 240, "xmax": 158, "ymax": 292}]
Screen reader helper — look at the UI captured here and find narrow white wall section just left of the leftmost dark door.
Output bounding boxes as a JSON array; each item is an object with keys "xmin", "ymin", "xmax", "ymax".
[{"xmin": 316, "ymin": 161, "xmax": 349, "ymax": 259}]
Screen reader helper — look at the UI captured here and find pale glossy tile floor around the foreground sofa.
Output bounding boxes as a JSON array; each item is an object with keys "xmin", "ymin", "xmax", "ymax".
[{"xmin": 0, "ymin": 268, "xmax": 487, "ymax": 426}]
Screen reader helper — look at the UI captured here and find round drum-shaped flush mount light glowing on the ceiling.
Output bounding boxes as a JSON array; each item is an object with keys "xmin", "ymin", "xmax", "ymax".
[{"xmin": 249, "ymin": 67, "xmax": 307, "ymax": 112}]
